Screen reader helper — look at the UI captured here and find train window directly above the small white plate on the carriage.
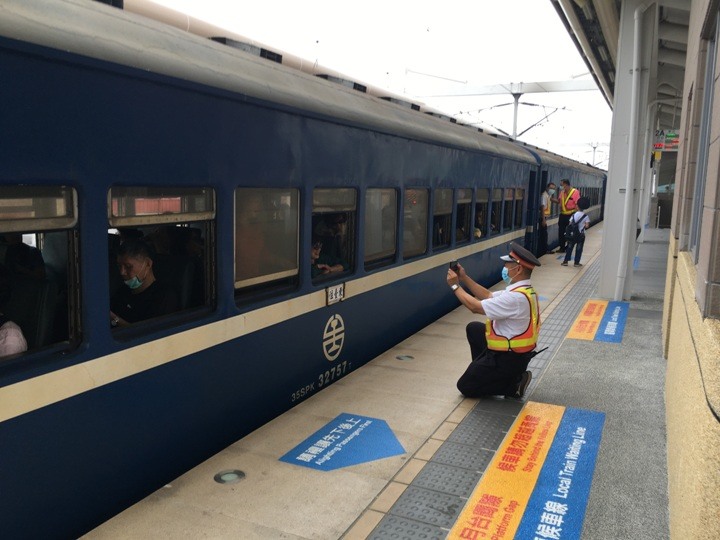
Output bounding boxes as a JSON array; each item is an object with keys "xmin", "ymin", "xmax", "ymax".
[{"xmin": 311, "ymin": 188, "xmax": 357, "ymax": 280}]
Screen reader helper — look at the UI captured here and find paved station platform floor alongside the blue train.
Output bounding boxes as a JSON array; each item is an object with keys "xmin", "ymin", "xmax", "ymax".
[{"xmin": 84, "ymin": 224, "xmax": 669, "ymax": 540}]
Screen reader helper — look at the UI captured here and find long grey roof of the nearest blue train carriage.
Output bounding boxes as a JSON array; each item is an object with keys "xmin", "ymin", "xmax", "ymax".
[{"xmin": 0, "ymin": 0, "xmax": 535, "ymax": 163}]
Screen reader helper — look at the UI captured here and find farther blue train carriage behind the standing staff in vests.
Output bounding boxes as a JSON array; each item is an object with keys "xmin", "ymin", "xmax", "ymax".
[{"xmin": 522, "ymin": 144, "xmax": 607, "ymax": 256}]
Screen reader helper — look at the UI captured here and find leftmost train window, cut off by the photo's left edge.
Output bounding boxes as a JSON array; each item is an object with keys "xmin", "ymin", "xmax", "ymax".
[{"xmin": 0, "ymin": 186, "xmax": 81, "ymax": 362}]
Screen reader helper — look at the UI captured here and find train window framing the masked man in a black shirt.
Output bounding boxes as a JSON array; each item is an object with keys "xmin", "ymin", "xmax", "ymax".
[{"xmin": 108, "ymin": 186, "xmax": 215, "ymax": 328}]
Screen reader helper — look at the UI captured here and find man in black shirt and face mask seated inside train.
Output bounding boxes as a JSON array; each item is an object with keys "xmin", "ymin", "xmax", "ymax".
[{"xmin": 110, "ymin": 240, "xmax": 178, "ymax": 327}]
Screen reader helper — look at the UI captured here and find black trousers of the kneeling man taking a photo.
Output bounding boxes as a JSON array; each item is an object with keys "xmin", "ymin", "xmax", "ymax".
[{"xmin": 457, "ymin": 322, "xmax": 535, "ymax": 397}]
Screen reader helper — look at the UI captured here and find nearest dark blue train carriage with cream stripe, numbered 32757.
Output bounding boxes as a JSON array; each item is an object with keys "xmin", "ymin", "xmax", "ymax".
[{"xmin": 0, "ymin": 0, "xmax": 576, "ymax": 538}]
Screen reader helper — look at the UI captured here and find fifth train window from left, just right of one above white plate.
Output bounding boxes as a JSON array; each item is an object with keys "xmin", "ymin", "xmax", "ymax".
[{"xmin": 365, "ymin": 189, "xmax": 397, "ymax": 269}]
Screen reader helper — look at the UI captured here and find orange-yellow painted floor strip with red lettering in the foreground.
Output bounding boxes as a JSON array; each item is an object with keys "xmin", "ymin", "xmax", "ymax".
[{"xmin": 447, "ymin": 402, "xmax": 565, "ymax": 540}]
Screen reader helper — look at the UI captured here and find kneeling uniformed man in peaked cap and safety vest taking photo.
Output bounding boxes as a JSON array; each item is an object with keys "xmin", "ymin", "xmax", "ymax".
[{"xmin": 447, "ymin": 242, "xmax": 540, "ymax": 399}]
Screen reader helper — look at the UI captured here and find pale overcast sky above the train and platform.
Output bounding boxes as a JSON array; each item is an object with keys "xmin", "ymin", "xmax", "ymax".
[{"xmin": 153, "ymin": 0, "xmax": 612, "ymax": 169}]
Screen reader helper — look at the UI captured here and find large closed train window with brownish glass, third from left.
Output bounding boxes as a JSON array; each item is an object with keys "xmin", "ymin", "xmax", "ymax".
[{"xmin": 235, "ymin": 188, "xmax": 300, "ymax": 296}]
